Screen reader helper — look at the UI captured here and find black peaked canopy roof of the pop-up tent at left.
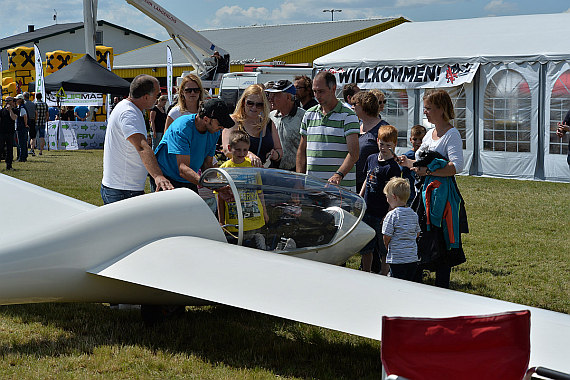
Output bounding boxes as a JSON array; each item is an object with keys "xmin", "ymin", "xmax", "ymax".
[{"xmin": 45, "ymin": 54, "xmax": 130, "ymax": 95}]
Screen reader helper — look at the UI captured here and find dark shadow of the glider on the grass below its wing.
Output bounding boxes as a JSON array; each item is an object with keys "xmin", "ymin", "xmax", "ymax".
[{"xmin": 0, "ymin": 304, "xmax": 382, "ymax": 379}]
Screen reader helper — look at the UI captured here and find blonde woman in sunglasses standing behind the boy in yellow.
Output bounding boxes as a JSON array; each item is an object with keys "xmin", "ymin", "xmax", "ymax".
[{"xmin": 222, "ymin": 84, "xmax": 283, "ymax": 167}]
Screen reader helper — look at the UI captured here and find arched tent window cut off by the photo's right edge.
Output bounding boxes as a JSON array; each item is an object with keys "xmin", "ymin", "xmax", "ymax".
[{"xmin": 549, "ymin": 70, "xmax": 570, "ymax": 155}]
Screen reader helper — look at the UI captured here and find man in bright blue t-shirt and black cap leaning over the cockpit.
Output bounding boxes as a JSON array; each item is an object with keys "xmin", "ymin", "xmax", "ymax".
[{"xmin": 151, "ymin": 99, "xmax": 235, "ymax": 192}]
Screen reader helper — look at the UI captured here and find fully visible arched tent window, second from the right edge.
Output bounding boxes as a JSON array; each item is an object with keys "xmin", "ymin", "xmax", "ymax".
[{"xmin": 483, "ymin": 70, "xmax": 531, "ymax": 152}]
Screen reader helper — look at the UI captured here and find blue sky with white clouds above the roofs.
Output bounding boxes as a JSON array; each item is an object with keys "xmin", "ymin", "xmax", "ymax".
[{"xmin": 0, "ymin": 0, "xmax": 570, "ymax": 40}]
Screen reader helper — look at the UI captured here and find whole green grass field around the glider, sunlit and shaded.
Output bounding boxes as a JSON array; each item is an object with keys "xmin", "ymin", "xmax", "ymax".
[{"xmin": 0, "ymin": 151, "xmax": 570, "ymax": 379}]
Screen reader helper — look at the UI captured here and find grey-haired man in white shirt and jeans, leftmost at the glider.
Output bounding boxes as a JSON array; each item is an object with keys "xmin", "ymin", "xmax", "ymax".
[{"xmin": 101, "ymin": 74, "xmax": 173, "ymax": 204}]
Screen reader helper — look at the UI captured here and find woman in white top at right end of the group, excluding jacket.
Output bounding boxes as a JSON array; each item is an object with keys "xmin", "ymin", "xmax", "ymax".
[{"xmin": 398, "ymin": 90, "xmax": 467, "ymax": 288}]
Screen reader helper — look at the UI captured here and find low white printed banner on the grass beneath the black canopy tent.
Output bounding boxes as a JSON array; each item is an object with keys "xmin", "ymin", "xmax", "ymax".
[{"xmin": 46, "ymin": 120, "xmax": 107, "ymax": 150}]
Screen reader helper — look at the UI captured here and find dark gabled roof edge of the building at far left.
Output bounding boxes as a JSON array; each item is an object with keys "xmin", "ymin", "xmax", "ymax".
[{"xmin": 0, "ymin": 20, "xmax": 159, "ymax": 50}]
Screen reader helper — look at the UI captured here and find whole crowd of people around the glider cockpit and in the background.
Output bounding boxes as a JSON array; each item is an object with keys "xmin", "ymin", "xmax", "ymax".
[{"xmin": 11, "ymin": 68, "xmax": 570, "ymax": 288}]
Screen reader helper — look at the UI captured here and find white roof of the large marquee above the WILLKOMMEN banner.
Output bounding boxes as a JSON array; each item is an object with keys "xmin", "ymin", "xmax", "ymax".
[{"xmin": 314, "ymin": 13, "xmax": 570, "ymax": 67}]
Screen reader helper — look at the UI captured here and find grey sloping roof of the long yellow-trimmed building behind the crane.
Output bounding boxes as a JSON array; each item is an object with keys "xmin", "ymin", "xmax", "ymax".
[{"xmin": 113, "ymin": 18, "xmax": 400, "ymax": 69}]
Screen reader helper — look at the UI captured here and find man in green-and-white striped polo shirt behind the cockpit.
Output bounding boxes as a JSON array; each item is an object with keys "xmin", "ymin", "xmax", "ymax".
[{"xmin": 297, "ymin": 71, "xmax": 360, "ymax": 191}]
